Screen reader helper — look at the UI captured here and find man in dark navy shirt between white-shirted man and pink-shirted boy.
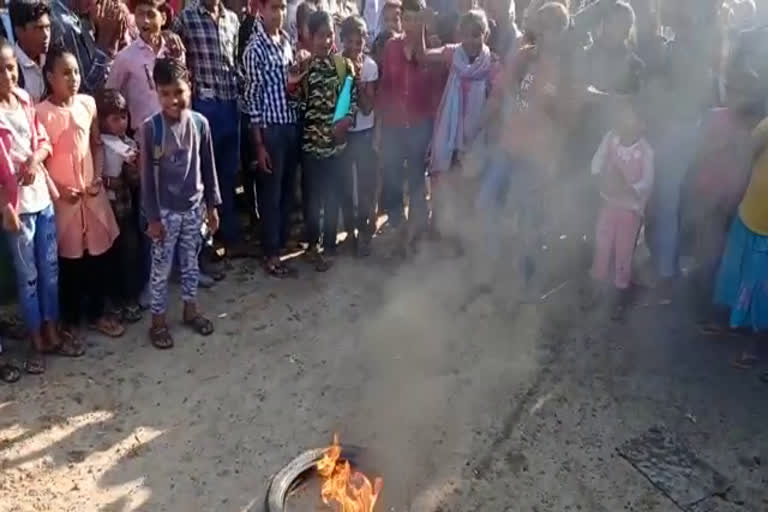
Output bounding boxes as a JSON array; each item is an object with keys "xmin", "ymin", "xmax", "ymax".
[{"xmin": 51, "ymin": 0, "xmax": 126, "ymax": 94}]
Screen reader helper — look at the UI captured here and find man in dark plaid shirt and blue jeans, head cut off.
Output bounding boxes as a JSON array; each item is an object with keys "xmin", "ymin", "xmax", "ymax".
[{"xmin": 171, "ymin": 0, "xmax": 240, "ymax": 256}]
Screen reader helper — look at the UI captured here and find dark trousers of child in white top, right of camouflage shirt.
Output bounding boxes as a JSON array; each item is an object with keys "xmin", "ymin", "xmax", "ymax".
[{"xmin": 340, "ymin": 129, "xmax": 378, "ymax": 239}]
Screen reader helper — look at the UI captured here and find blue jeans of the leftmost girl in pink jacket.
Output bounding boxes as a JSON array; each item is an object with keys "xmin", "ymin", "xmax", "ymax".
[{"xmin": 7, "ymin": 204, "xmax": 59, "ymax": 331}]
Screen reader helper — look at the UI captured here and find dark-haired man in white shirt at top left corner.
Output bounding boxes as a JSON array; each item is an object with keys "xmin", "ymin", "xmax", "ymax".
[{"xmin": 8, "ymin": 0, "xmax": 51, "ymax": 103}]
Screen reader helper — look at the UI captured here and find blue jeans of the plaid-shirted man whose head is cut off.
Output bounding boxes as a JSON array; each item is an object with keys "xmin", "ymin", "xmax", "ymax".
[{"xmin": 192, "ymin": 97, "xmax": 240, "ymax": 243}]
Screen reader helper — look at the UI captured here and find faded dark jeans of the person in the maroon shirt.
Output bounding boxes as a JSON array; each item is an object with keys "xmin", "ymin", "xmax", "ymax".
[{"xmin": 381, "ymin": 120, "xmax": 432, "ymax": 226}]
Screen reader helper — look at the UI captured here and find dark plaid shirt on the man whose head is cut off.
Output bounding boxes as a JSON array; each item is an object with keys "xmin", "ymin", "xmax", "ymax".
[{"xmin": 171, "ymin": 4, "xmax": 240, "ymax": 100}]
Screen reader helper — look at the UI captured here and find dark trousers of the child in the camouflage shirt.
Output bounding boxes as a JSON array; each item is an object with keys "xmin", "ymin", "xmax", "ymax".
[{"xmin": 301, "ymin": 154, "xmax": 344, "ymax": 249}]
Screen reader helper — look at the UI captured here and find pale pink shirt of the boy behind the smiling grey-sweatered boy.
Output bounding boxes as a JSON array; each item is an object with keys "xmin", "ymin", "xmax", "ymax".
[{"xmin": 104, "ymin": 38, "xmax": 180, "ymax": 130}]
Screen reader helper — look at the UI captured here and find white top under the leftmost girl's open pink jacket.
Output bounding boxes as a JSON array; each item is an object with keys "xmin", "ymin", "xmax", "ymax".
[{"xmin": 0, "ymin": 104, "xmax": 51, "ymax": 213}]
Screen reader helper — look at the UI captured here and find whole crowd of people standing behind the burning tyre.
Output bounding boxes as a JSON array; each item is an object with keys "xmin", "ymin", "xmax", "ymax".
[{"xmin": 0, "ymin": 0, "xmax": 768, "ymax": 381}]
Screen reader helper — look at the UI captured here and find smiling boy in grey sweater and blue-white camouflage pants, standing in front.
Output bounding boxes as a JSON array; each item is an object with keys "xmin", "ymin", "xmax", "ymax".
[{"xmin": 139, "ymin": 58, "xmax": 221, "ymax": 349}]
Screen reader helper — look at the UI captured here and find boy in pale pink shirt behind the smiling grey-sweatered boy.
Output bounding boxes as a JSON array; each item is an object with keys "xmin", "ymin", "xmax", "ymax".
[{"xmin": 105, "ymin": 0, "xmax": 184, "ymax": 136}]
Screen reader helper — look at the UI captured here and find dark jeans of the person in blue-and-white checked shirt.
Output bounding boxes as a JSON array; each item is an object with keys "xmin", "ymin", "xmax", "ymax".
[{"xmin": 254, "ymin": 124, "xmax": 301, "ymax": 257}]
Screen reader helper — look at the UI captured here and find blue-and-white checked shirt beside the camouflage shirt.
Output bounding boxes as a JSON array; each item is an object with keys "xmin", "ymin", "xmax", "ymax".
[{"xmin": 243, "ymin": 22, "xmax": 298, "ymax": 127}]
